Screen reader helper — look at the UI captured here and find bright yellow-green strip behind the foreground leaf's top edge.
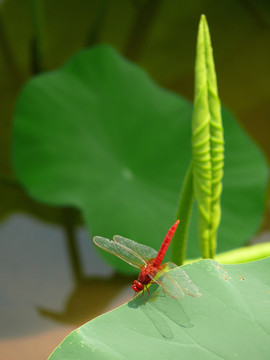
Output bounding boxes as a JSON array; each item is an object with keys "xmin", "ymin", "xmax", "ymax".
[{"xmin": 185, "ymin": 242, "xmax": 270, "ymax": 264}]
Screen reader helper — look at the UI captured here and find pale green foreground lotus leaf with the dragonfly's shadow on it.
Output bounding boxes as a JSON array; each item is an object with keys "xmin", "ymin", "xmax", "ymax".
[{"xmin": 49, "ymin": 258, "xmax": 270, "ymax": 360}]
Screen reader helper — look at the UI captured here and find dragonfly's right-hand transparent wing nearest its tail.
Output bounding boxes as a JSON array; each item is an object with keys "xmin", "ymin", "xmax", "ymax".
[{"xmin": 166, "ymin": 262, "xmax": 201, "ymax": 297}]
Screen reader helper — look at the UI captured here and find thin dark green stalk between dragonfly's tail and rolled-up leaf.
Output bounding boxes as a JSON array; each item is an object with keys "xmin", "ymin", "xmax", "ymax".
[{"xmin": 171, "ymin": 163, "xmax": 194, "ymax": 266}]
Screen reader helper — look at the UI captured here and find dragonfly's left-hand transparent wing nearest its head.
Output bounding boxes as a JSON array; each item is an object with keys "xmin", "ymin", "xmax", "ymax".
[{"xmin": 93, "ymin": 236, "xmax": 146, "ymax": 269}]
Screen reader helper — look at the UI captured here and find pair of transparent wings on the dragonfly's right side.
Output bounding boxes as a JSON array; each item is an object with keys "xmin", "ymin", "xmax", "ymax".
[{"xmin": 149, "ymin": 263, "xmax": 201, "ymax": 299}]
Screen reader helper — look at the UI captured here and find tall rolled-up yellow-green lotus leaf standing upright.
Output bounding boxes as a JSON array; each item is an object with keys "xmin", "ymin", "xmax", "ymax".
[{"xmin": 192, "ymin": 15, "xmax": 224, "ymax": 258}]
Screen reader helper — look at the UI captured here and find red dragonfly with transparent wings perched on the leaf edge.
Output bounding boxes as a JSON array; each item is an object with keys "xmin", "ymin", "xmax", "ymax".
[{"xmin": 93, "ymin": 220, "xmax": 201, "ymax": 299}]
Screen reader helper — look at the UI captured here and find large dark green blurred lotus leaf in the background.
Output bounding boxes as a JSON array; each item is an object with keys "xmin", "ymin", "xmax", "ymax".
[{"xmin": 13, "ymin": 46, "xmax": 267, "ymax": 273}]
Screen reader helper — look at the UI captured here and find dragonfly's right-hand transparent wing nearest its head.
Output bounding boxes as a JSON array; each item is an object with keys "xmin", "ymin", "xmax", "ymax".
[{"xmin": 149, "ymin": 269, "xmax": 184, "ymax": 299}]
